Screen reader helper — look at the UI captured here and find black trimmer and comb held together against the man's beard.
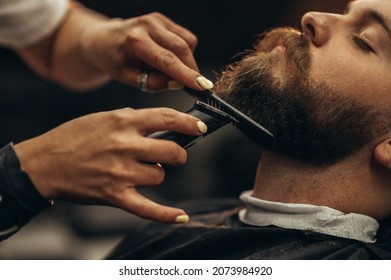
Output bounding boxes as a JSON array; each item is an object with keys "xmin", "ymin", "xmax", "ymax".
[{"xmin": 148, "ymin": 88, "xmax": 275, "ymax": 149}]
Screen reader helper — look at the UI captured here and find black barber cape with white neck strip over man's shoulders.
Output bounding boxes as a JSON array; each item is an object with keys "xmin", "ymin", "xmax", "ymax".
[{"xmin": 107, "ymin": 193, "xmax": 391, "ymax": 260}]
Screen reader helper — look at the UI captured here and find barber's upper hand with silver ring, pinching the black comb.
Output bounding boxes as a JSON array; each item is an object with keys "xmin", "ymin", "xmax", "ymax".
[{"xmin": 80, "ymin": 13, "xmax": 213, "ymax": 91}]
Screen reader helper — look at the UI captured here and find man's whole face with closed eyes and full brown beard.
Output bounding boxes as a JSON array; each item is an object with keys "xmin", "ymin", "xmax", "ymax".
[{"xmin": 215, "ymin": 0, "xmax": 391, "ymax": 164}]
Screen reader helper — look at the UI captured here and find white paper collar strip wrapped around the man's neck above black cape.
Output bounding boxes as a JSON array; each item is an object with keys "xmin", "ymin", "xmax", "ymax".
[{"xmin": 239, "ymin": 191, "xmax": 379, "ymax": 243}]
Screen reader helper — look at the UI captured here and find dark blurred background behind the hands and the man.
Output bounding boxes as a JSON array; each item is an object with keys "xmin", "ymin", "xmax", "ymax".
[{"xmin": 0, "ymin": 0, "xmax": 347, "ymax": 259}]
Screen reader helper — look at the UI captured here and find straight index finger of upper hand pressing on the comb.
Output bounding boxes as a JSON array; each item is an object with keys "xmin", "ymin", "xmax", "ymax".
[{"xmin": 126, "ymin": 38, "xmax": 205, "ymax": 90}]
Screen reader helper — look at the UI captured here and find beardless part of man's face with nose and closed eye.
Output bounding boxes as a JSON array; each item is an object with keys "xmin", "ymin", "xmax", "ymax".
[{"xmin": 308, "ymin": 0, "xmax": 391, "ymax": 108}]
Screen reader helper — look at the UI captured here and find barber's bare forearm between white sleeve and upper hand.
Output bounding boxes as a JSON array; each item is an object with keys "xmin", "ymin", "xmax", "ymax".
[{"xmin": 17, "ymin": 1, "xmax": 110, "ymax": 90}]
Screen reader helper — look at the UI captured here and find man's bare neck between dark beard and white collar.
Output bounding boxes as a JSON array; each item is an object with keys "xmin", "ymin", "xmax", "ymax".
[{"xmin": 253, "ymin": 152, "xmax": 391, "ymax": 219}]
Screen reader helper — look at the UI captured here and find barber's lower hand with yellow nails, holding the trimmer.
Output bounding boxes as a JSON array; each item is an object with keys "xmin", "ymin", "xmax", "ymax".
[{"xmin": 15, "ymin": 108, "xmax": 206, "ymax": 222}]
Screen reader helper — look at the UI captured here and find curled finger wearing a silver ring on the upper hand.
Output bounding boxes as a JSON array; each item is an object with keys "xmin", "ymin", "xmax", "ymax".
[{"xmin": 115, "ymin": 66, "xmax": 183, "ymax": 92}]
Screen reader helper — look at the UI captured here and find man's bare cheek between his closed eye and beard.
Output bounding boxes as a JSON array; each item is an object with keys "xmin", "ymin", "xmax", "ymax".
[{"xmin": 310, "ymin": 49, "xmax": 391, "ymax": 104}]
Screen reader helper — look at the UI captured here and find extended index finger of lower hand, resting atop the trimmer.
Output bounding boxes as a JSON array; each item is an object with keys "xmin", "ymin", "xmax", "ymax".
[{"xmin": 132, "ymin": 108, "xmax": 207, "ymax": 135}]
